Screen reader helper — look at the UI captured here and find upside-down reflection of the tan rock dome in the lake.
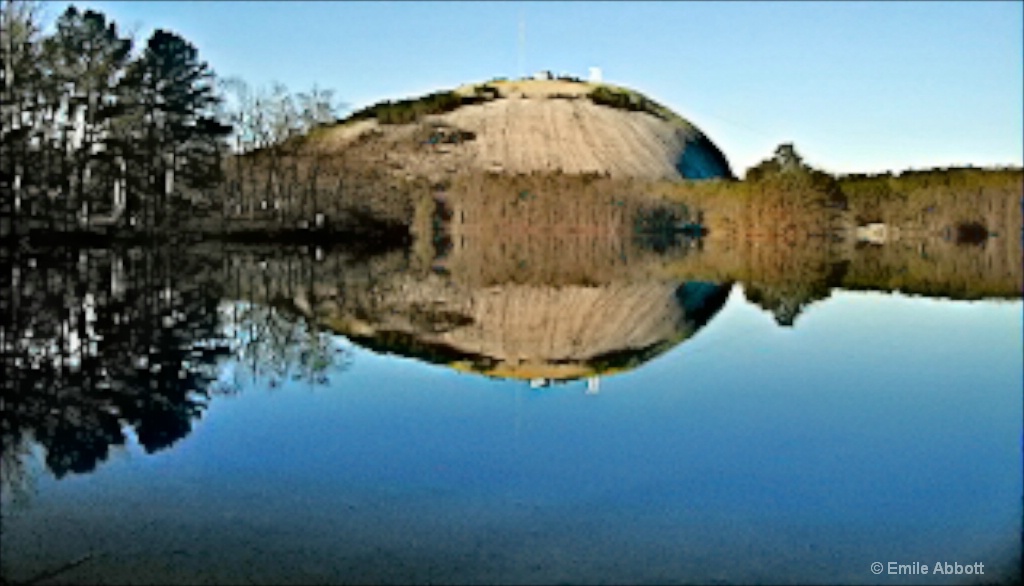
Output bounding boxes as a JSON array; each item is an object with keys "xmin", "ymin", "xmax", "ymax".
[{"xmin": 326, "ymin": 281, "xmax": 729, "ymax": 379}]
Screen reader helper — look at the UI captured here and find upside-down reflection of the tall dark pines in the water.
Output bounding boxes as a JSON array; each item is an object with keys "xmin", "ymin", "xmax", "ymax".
[{"xmin": 2, "ymin": 250, "xmax": 227, "ymax": 477}]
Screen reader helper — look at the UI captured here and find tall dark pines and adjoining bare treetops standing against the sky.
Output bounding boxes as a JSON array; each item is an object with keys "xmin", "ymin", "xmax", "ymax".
[{"xmin": 0, "ymin": 0, "xmax": 340, "ymax": 232}]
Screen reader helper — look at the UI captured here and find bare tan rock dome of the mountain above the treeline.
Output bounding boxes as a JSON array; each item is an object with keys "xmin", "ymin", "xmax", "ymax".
[{"xmin": 323, "ymin": 81, "xmax": 732, "ymax": 180}]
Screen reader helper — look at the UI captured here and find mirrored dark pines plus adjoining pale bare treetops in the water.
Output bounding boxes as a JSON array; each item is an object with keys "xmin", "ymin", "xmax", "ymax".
[{"xmin": 0, "ymin": 242, "xmax": 356, "ymax": 493}]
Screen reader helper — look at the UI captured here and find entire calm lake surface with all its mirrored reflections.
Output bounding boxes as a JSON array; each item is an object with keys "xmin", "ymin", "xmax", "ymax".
[{"xmin": 0, "ymin": 234, "xmax": 1024, "ymax": 584}]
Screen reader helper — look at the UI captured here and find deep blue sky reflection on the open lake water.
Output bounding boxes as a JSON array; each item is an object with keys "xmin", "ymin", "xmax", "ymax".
[{"xmin": 4, "ymin": 288, "xmax": 1024, "ymax": 583}]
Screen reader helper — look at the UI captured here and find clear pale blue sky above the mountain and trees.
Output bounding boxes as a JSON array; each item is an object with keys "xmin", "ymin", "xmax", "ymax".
[{"xmin": 46, "ymin": 1, "xmax": 1024, "ymax": 174}]
